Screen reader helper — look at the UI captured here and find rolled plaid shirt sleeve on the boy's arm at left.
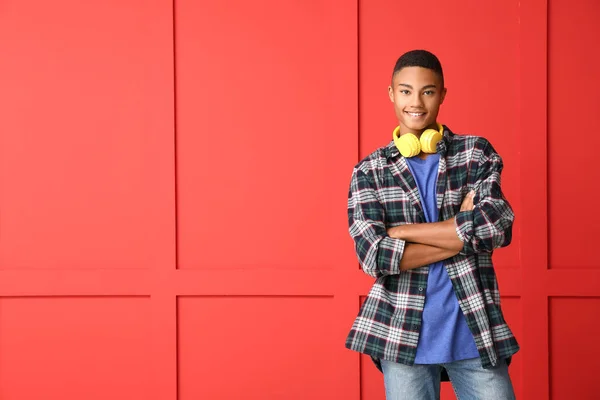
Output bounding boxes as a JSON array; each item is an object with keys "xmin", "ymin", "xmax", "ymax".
[{"xmin": 348, "ymin": 169, "xmax": 405, "ymax": 278}]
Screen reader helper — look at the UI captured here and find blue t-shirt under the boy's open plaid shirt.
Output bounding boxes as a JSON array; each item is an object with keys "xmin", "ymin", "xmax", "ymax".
[{"xmin": 406, "ymin": 154, "xmax": 479, "ymax": 364}]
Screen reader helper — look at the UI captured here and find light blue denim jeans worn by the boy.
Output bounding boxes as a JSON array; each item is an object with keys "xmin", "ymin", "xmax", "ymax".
[{"xmin": 381, "ymin": 358, "xmax": 515, "ymax": 400}]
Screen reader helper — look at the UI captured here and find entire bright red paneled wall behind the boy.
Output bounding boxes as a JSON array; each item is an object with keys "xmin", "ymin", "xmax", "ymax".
[{"xmin": 0, "ymin": 0, "xmax": 600, "ymax": 400}]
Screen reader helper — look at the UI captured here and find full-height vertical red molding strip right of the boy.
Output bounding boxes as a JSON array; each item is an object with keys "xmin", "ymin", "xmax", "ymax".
[{"xmin": 519, "ymin": 0, "xmax": 550, "ymax": 399}]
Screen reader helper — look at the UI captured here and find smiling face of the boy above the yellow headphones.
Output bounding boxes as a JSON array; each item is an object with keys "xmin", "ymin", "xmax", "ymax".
[{"xmin": 388, "ymin": 67, "xmax": 446, "ymax": 134}]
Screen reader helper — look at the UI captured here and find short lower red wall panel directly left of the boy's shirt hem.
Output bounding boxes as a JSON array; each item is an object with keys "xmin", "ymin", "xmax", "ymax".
[{"xmin": 178, "ymin": 296, "xmax": 342, "ymax": 400}]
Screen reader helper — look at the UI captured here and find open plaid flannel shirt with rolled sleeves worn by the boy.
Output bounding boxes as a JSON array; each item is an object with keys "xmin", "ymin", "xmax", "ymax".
[{"xmin": 346, "ymin": 126, "xmax": 519, "ymax": 370}]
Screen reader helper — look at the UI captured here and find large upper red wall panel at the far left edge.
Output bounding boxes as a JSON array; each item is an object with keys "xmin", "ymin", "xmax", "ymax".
[{"xmin": 0, "ymin": 0, "xmax": 174, "ymax": 269}]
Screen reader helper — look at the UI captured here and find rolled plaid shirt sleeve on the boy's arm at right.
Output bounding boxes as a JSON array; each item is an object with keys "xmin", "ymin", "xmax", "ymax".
[{"xmin": 456, "ymin": 140, "xmax": 515, "ymax": 255}]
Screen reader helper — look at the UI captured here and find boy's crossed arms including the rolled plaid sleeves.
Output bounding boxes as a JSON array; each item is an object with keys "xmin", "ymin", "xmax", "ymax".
[{"xmin": 348, "ymin": 138, "xmax": 514, "ymax": 278}]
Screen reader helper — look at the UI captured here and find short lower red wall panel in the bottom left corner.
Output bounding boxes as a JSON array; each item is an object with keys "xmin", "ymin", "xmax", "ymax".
[{"xmin": 0, "ymin": 297, "xmax": 153, "ymax": 400}]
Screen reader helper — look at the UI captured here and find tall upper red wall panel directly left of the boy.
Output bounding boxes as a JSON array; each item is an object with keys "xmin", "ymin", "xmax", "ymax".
[{"xmin": 176, "ymin": 0, "xmax": 357, "ymax": 269}]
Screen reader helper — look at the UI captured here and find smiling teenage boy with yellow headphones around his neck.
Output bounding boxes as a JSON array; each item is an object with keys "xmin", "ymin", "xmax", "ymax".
[{"xmin": 346, "ymin": 50, "xmax": 519, "ymax": 400}]
